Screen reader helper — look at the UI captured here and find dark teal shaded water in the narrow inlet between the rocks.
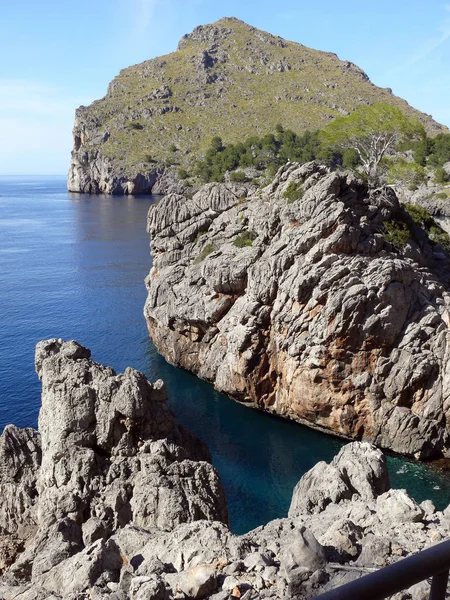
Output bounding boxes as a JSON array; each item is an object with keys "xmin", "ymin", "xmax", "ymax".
[{"xmin": 142, "ymin": 341, "xmax": 450, "ymax": 533}]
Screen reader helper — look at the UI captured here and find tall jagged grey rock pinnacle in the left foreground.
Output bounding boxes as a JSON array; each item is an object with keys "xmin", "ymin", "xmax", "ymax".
[{"xmin": 36, "ymin": 340, "xmax": 227, "ymax": 529}]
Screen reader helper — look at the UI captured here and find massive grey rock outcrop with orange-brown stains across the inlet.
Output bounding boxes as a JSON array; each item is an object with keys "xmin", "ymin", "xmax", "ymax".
[{"xmin": 145, "ymin": 163, "xmax": 450, "ymax": 458}]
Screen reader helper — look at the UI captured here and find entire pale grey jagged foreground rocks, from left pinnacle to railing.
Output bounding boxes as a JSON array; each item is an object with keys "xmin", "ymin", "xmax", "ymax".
[{"xmin": 0, "ymin": 339, "xmax": 450, "ymax": 600}]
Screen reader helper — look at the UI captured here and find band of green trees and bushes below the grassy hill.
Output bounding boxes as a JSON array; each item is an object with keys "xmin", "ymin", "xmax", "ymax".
[{"xmin": 189, "ymin": 104, "xmax": 450, "ymax": 190}]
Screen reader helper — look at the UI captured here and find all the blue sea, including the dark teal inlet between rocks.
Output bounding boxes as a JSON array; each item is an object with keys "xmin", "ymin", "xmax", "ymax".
[{"xmin": 0, "ymin": 176, "xmax": 450, "ymax": 533}]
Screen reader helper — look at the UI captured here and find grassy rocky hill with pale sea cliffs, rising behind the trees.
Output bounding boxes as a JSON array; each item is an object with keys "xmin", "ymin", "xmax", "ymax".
[{"xmin": 68, "ymin": 18, "xmax": 446, "ymax": 194}]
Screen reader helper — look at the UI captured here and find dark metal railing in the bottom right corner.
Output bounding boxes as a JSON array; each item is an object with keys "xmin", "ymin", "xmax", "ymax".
[{"xmin": 316, "ymin": 541, "xmax": 450, "ymax": 600}]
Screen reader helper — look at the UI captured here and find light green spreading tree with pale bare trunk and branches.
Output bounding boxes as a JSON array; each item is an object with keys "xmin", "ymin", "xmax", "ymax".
[{"xmin": 321, "ymin": 102, "xmax": 425, "ymax": 181}]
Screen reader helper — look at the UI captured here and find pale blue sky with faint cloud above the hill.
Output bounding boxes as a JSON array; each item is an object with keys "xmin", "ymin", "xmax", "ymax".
[{"xmin": 0, "ymin": 0, "xmax": 450, "ymax": 174}]
